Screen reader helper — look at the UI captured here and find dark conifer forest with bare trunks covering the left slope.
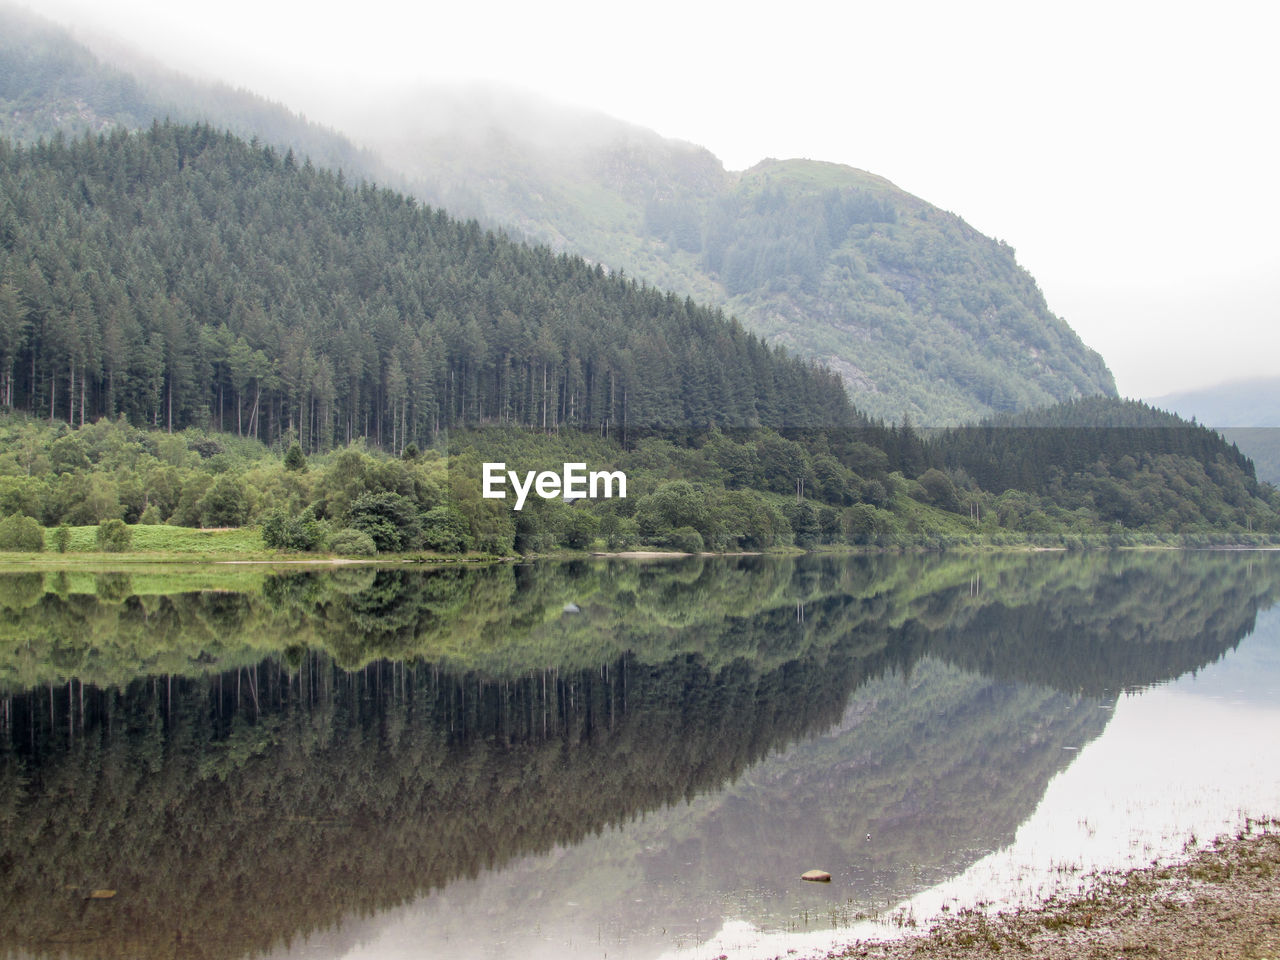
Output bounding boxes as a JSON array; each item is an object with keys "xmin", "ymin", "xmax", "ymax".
[{"xmin": 0, "ymin": 124, "xmax": 852, "ymax": 452}]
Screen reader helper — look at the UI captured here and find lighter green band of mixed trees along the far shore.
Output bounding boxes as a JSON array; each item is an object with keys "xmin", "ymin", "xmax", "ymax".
[{"xmin": 0, "ymin": 401, "xmax": 1280, "ymax": 554}]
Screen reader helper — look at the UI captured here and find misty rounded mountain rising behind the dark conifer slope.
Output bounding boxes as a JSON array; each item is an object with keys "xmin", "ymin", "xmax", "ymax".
[{"xmin": 344, "ymin": 88, "xmax": 1115, "ymax": 424}]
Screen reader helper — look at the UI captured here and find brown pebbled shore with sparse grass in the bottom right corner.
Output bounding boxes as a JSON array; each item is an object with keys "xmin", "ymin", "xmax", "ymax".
[{"xmin": 827, "ymin": 820, "xmax": 1280, "ymax": 960}]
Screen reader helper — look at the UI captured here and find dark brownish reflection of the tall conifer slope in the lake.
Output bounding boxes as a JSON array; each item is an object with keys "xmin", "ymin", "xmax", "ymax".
[{"xmin": 0, "ymin": 654, "xmax": 881, "ymax": 956}]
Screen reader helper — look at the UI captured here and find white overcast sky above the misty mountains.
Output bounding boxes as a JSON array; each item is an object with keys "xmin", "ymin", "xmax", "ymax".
[{"xmin": 28, "ymin": 0, "xmax": 1280, "ymax": 397}]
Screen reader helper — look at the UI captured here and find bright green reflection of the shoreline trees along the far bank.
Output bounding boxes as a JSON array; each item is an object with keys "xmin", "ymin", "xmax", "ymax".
[{"xmin": 10, "ymin": 553, "xmax": 1280, "ymax": 691}]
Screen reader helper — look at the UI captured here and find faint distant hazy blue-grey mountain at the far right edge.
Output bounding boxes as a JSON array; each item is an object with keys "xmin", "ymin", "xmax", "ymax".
[{"xmin": 1151, "ymin": 376, "xmax": 1280, "ymax": 484}]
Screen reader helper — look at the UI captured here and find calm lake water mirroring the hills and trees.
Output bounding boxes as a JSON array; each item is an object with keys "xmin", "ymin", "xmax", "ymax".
[{"xmin": 0, "ymin": 552, "xmax": 1280, "ymax": 960}]
